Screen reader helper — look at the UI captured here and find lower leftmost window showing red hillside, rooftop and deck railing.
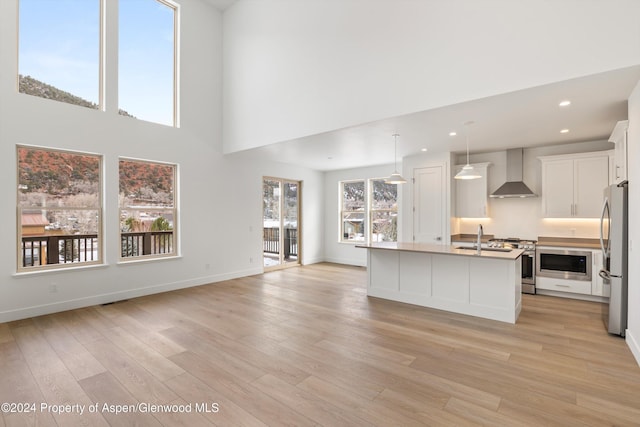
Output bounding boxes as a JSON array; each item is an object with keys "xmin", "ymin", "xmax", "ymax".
[{"xmin": 17, "ymin": 146, "xmax": 102, "ymax": 271}]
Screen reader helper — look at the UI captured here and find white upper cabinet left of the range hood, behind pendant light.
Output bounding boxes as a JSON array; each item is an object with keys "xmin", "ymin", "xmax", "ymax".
[{"xmin": 454, "ymin": 163, "xmax": 491, "ymax": 218}]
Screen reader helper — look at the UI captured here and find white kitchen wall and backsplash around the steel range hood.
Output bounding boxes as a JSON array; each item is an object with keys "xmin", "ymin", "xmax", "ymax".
[{"xmin": 457, "ymin": 140, "xmax": 623, "ymax": 239}]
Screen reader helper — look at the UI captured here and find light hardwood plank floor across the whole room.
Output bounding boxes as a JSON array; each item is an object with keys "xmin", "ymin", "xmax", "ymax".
[{"xmin": 0, "ymin": 264, "xmax": 640, "ymax": 427}]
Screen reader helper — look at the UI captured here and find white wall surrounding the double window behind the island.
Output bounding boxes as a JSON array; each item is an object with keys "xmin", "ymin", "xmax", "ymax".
[{"xmin": 324, "ymin": 164, "xmax": 406, "ymax": 266}]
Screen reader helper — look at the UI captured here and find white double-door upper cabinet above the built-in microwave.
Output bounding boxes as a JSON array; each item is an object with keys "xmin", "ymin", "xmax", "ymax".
[{"xmin": 539, "ymin": 151, "xmax": 612, "ymax": 218}]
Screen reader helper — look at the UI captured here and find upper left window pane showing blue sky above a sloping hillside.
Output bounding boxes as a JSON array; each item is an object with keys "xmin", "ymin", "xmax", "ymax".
[{"xmin": 18, "ymin": 0, "xmax": 100, "ymax": 108}]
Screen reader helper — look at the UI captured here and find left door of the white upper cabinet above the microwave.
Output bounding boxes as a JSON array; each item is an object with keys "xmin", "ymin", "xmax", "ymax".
[{"xmin": 542, "ymin": 160, "xmax": 576, "ymax": 218}]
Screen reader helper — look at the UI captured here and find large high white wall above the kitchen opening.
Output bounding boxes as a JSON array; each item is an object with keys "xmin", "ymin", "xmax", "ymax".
[{"xmin": 223, "ymin": 0, "xmax": 640, "ymax": 152}]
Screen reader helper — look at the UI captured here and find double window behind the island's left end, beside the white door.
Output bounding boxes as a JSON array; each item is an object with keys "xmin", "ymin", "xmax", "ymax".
[{"xmin": 340, "ymin": 179, "xmax": 398, "ymax": 242}]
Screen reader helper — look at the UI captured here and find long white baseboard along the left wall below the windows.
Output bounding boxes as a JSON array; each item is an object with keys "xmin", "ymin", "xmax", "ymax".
[{"xmin": 0, "ymin": 267, "xmax": 263, "ymax": 323}]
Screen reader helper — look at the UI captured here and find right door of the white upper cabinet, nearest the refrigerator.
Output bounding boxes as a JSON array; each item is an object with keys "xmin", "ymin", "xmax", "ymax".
[{"xmin": 573, "ymin": 155, "xmax": 609, "ymax": 218}]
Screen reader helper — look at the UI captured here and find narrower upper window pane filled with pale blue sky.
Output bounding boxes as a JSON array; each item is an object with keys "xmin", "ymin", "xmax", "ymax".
[{"xmin": 118, "ymin": 0, "xmax": 176, "ymax": 126}]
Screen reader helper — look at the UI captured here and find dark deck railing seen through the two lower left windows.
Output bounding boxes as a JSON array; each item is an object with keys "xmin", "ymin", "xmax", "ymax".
[{"xmin": 21, "ymin": 231, "xmax": 174, "ymax": 267}]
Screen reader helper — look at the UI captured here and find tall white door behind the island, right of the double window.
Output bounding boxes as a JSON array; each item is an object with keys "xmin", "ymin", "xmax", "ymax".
[{"xmin": 413, "ymin": 166, "xmax": 448, "ymax": 243}]
